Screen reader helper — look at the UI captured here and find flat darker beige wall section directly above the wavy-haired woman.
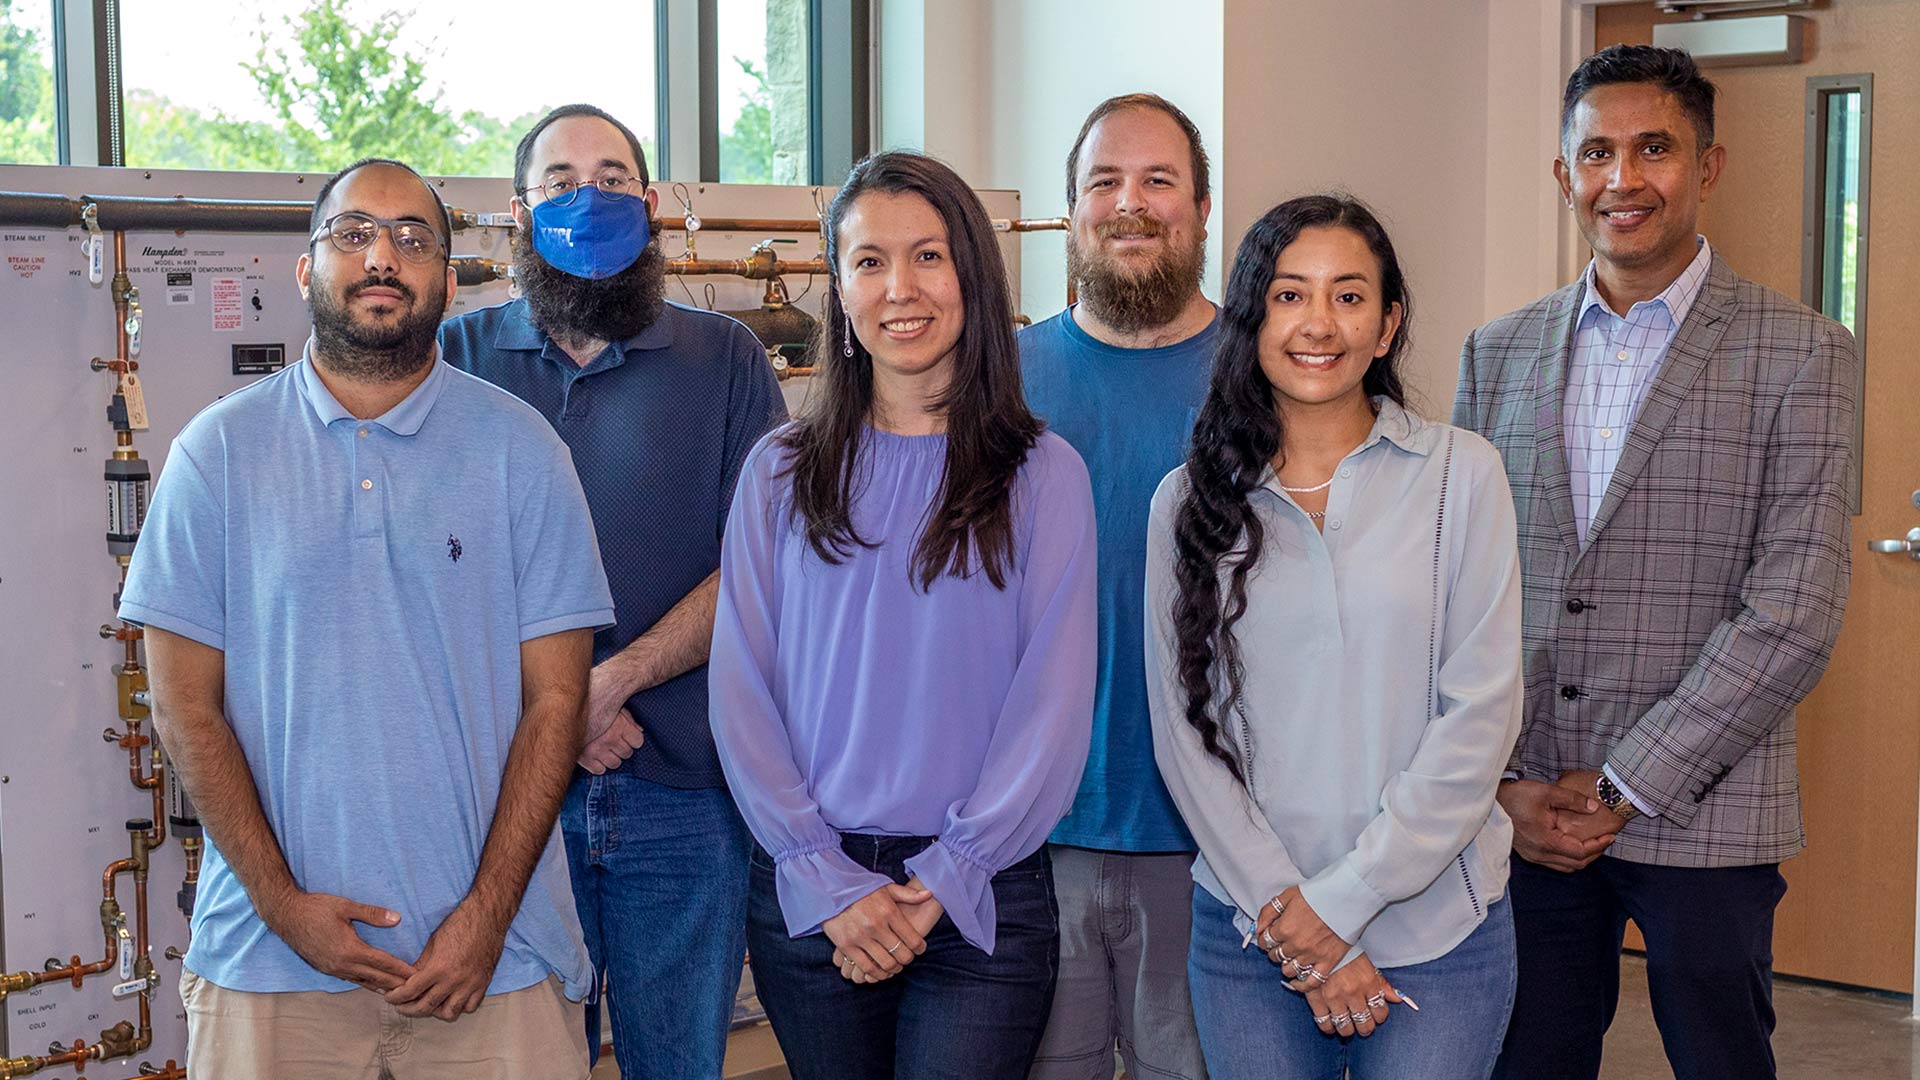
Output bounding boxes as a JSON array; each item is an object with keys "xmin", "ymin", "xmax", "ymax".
[{"xmin": 1225, "ymin": 0, "xmax": 1488, "ymax": 415}]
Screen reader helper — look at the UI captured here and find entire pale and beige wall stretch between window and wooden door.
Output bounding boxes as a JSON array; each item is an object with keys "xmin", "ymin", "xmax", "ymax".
[{"xmin": 877, "ymin": 0, "xmax": 1580, "ymax": 399}]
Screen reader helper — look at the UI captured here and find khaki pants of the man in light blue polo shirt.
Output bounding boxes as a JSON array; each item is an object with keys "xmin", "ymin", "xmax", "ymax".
[{"xmin": 180, "ymin": 969, "xmax": 588, "ymax": 1080}]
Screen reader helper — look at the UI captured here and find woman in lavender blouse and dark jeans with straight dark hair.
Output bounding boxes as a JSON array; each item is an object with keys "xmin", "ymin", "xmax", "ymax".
[{"xmin": 708, "ymin": 154, "xmax": 1094, "ymax": 1080}]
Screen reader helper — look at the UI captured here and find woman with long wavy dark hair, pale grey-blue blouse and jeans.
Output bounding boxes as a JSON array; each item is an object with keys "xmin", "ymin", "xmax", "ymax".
[{"xmin": 1146, "ymin": 196, "xmax": 1521, "ymax": 1080}]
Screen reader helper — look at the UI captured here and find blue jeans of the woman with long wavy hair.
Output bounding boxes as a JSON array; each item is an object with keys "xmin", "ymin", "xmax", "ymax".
[{"xmin": 1187, "ymin": 886, "xmax": 1517, "ymax": 1080}]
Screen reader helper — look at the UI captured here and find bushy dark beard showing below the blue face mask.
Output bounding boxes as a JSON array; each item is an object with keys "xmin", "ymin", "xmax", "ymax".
[{"xmin": 513, "ymin": 229, "xmax": 666, "ymax": 342}]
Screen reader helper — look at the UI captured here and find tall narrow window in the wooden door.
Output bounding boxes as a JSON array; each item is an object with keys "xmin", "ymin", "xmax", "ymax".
[{"xmin": 1801, "ymin": 75, "xmax": 1874, "ymax": 513}]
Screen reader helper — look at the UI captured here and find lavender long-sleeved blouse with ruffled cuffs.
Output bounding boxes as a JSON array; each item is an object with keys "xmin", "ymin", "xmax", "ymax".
[{"xmin": 708, "ymin": 429, "xmax": 1096, "ymax": 953}]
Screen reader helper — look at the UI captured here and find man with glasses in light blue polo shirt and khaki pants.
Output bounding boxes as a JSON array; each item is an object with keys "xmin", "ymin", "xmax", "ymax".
[{"xmin": 121, "ymin": 161, "xmax": 612, "ymax": 1078}]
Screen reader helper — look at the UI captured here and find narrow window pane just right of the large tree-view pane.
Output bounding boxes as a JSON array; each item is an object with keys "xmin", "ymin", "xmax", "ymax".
[{"xmin": 716, "ymin": 0, "xmax": 814, "ymax": 184}]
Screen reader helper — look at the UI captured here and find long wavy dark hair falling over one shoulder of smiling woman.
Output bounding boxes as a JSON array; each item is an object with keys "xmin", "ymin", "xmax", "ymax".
[{"xmin": 1173, "ymin": 194, "xmax": 1413, "ymax": 784}]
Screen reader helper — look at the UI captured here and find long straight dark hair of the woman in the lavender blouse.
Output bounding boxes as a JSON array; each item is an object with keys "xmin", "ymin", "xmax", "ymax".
[{"xmin": 781, "ymin": 150, "xmax": 1041, "ymax": 590}]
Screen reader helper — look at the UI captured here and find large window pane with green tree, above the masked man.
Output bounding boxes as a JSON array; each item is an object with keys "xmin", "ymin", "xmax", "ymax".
[{"xmin": 121, "ymin": 0, "xmax": 659, "ymax": 177}]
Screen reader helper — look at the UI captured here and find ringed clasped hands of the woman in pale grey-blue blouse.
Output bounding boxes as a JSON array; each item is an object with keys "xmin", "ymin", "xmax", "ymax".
[{"xmin": 1254, "ymin": 886, "xmax": 1404, "ymax": 1038}]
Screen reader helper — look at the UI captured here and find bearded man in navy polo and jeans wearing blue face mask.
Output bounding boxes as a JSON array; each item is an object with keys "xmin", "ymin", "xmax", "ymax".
[{"xmin": 440, "ymin": 106, "xmax": 787, "ymax": 1080}]
